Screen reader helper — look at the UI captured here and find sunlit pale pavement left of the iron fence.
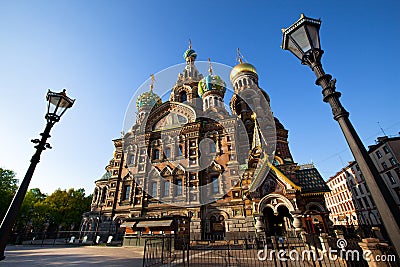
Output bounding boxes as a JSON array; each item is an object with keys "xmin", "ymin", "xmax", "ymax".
[{"xmin": 0, "ymin": 246, "xmax": 143, "ymax": 267}]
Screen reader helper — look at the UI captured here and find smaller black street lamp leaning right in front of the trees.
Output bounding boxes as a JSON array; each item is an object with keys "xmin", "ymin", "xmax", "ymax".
[{"xmin": 0, "ymin": 89, "xmax": 75, "ymax": 261}]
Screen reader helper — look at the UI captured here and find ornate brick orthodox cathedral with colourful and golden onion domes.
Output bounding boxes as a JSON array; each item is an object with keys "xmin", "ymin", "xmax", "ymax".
[{"xmin": 81, "ymin": 46, "xmax": 329, "ymax": 243}]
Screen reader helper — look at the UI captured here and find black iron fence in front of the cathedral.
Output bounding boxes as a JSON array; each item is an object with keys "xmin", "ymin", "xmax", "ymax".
[{"xmin": 143, "ymin": 235, "xmax": 398, "ymax": 267}]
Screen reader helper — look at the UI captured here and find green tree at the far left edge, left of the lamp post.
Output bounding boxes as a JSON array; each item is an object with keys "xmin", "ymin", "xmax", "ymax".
[{"xmin": 0, "ymin": 168, "xmax": 18, "ymax": 221}]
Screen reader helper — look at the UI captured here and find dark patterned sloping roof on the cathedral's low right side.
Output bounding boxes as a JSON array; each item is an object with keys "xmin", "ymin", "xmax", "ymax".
[{"xmin": 295, "ymin": 167, "xmax": 330, "ymax": 193}]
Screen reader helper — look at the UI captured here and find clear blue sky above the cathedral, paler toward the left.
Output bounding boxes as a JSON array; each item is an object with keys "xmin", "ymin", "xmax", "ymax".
[{"xmin": 0, "ymin": 0, "xmax": 400, "ymax": 196}]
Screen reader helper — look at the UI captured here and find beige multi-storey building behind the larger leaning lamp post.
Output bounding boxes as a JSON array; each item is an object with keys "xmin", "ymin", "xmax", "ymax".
[{"xmin": 325, "ymin": 136, "xmax": 400, "ymax": 226}]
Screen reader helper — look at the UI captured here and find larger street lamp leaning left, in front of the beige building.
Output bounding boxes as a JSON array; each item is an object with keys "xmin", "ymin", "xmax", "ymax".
[{"xmin": 282, "ymin": 14, "xmax": 400, "ymax": 254}]
